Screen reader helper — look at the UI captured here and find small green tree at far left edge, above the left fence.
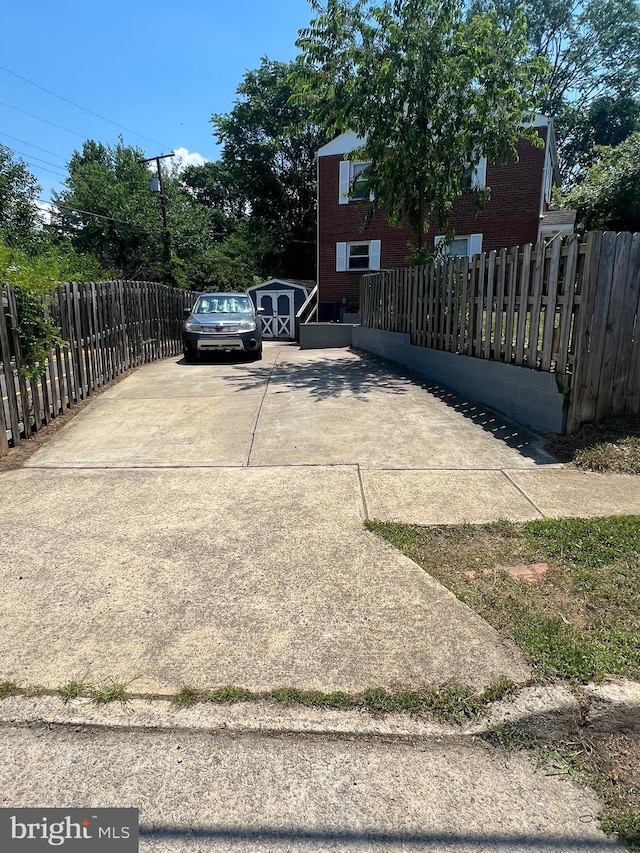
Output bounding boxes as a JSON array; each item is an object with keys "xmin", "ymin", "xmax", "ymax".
[{"xmin": 0, "ymin": 145, "xmax": 40, "ymax": 248}]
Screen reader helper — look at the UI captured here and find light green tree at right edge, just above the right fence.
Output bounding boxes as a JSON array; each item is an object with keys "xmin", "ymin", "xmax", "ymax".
[{"xmin": 564, "ymin": 132, "xmax": 640, "ymax": 231}]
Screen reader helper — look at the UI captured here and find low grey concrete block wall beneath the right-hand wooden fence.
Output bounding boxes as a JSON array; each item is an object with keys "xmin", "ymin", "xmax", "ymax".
[{"xmin": 352, "ymin": 326, "xmax": 565, "ymax": 432}]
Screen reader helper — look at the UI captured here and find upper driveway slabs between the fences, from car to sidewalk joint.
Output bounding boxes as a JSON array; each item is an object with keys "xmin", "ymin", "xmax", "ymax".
[{"xmin": 25, "ymin": 345, "xmax": 553, "ymax": 470}]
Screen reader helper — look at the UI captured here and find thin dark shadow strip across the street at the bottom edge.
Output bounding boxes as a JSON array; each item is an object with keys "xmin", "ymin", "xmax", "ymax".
[{"xmin": 139, "ymin": 825, "xmax": 622, "ymax": 853}]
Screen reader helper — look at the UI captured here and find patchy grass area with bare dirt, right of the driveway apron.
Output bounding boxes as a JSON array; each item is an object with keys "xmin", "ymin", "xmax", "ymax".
[{"xmin": 366, "ymin": 516, "xmax": 640, "ymax": 682}]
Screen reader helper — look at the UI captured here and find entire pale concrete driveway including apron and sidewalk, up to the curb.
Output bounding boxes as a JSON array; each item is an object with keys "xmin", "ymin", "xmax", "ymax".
[{"xmin": 0, "ymin": 345, "xmax": 640, "ymax": 694}]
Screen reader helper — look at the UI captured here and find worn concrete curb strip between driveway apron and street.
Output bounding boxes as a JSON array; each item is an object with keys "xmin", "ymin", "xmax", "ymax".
[{"xmin": 0, "ymin": 679, "xmax": 640, "ymax": 741}]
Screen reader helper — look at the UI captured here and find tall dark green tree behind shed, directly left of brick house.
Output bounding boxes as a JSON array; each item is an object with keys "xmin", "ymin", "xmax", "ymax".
[{"xmin": 212, "ymin": 57, "xmax": 326, "ymax": 278}]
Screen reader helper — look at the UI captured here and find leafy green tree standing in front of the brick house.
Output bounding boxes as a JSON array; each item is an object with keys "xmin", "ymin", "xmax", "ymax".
[{"xmin": 293, "ymin": 0, "xmax": 541, "ymax": 257}]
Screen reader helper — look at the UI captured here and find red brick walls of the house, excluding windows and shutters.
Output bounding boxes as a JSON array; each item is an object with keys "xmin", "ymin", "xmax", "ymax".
[{"xmin": 318, "ymin": 128, "xmax": 546, "ymax": 309}]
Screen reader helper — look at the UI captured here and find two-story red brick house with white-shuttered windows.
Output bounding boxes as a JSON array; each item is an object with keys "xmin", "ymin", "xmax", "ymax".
[{"xmin": 317, "ymin": 116, "xmax": 575, "ymax": 320}]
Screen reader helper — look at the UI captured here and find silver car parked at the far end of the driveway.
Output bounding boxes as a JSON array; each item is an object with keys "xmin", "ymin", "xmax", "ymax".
[{"xmin": 182, "ymin": 293, "xmax": 263, "ymax": 361}]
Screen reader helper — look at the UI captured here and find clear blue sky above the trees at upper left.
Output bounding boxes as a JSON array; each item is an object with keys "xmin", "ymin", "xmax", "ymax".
[{"xmin": 0, "ymin": 0, "xmax": 313, "ymax": 200}]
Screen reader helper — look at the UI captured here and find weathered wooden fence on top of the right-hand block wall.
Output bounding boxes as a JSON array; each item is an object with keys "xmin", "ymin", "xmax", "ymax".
[{"xmin": 360, "ymin": 232, "xmax": 640, "ymax": 431}]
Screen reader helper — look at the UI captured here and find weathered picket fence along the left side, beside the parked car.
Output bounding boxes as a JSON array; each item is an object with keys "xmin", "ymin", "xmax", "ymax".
[{"xmin": 0, "ymin": 281, "xmax": 199, "ymax": 456}]
